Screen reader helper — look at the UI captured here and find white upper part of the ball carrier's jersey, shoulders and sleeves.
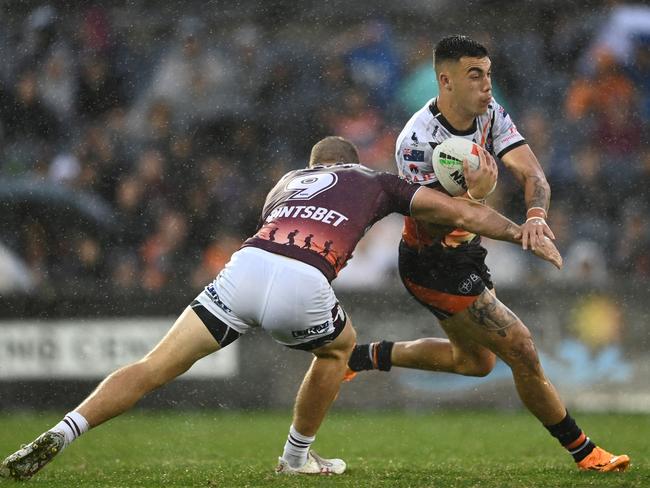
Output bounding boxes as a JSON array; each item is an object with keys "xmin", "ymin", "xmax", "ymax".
[{"xmin": 395, "ymin": 98, "xmax": 524, "ymax": 185}]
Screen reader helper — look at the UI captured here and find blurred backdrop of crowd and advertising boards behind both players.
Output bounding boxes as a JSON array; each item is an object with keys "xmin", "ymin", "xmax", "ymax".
[{"xmin": 0, "ymin": 0, "xmax": 650, "ymax": 412}]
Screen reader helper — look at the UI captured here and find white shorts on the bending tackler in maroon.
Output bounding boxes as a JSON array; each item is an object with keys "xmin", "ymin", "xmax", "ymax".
[{"xmin": 196, "ymin": 247, "xmax": 345, "ymax": 350}]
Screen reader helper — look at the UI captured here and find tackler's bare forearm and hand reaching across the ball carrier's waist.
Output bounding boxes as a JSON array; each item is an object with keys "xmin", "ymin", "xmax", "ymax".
[{"xmin": 411, "ymin": 187, "xmax": 562, "ymax": 269}]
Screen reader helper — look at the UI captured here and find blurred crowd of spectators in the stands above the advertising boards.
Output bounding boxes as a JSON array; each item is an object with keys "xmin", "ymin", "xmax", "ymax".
[{"xmin": 0, "ymin": 2, "xmax": 650, "ymax": 297}]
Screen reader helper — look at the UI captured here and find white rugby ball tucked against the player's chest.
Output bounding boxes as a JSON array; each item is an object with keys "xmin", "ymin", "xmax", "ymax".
[{"xmin": 432, "ymin": 136, "xmax": 480, "ymax": 197}]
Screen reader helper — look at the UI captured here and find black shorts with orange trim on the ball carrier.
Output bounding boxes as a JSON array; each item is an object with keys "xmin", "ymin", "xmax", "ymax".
[{"xmin": 399, "ymin": 236, "xmax": 494, "ymax": 320}]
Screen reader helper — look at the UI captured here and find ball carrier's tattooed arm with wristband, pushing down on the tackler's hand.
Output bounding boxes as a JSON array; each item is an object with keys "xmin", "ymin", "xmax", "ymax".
[{"xmin": 501, "ymin": 144, "xmax": 555, "ymax": 249}]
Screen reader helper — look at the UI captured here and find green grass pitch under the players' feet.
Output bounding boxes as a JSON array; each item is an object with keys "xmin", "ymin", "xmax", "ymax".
[{"xmin": 0, "ymin": 411, "xmax": 650, "ymax": 488}]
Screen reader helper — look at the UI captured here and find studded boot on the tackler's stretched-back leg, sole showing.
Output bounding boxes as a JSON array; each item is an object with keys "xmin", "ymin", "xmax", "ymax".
[{"xmin": 0, "ymin": 431, "xmax": 64, "ymax": 481}]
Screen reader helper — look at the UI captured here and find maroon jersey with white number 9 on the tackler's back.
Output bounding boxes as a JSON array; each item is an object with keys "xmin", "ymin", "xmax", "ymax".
[{"xmin": 242, "ymin": 164, "xmax": 420, "ymax": 281}]
